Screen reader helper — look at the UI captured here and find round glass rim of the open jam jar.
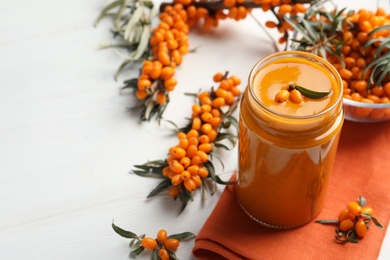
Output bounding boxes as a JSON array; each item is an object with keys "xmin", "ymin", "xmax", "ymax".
[{"xmin": 248, "ymin": 51, "xmax": 343, "ymax": 119}]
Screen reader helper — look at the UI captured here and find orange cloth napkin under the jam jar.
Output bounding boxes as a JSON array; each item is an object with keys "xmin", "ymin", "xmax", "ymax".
[{"xmin": 193, "ymin": 121, "xmax": 390, "ymax": 260}]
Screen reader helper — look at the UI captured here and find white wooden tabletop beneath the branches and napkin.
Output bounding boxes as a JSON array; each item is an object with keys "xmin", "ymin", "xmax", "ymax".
[{"xmin": 0, "ymin": 0, "xmax": 390, "ymax": 260}]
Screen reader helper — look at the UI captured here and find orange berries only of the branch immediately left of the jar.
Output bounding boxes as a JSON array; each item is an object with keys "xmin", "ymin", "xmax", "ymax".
[{"xmin": 162, "ymin": 73, "xmax": 241, "ymax": 197}]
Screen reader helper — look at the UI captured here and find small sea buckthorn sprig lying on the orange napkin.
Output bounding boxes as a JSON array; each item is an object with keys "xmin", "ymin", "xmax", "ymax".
[{"xmin": 315, "ymin": 196, "xmax": 383, "ymax": 244}]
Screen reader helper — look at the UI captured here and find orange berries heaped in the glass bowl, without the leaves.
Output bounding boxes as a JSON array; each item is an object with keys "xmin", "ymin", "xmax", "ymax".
[{"xmin": 332, "ymin": 8, "xmax": 390, "ymax": 103}]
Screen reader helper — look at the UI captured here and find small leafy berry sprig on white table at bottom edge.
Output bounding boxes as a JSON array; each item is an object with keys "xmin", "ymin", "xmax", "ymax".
[{"xmin": 112, "ymin": 222, "xmax": 195, "ymax": 260}]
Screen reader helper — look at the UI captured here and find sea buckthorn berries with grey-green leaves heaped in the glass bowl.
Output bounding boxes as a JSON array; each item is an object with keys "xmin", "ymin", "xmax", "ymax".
[{"xmin": 286, "ymin": 0, "xmax": 390, "ymax": 119}]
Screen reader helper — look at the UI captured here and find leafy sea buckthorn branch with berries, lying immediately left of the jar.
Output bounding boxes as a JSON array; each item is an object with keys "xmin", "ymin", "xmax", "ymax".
[{"xmin": 133, "ymin": 72, "xmax": 241, "ymax": 212}]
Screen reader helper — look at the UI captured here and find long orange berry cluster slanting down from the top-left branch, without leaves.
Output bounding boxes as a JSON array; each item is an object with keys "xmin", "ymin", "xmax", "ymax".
[{"xmin": 136, "ymin": 4, "xmax": 189, "ymax": 105}]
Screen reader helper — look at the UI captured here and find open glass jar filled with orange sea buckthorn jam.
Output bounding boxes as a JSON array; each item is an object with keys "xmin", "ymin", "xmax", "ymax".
[{"xmin": 236, "ymin": 51, "xmax": 344, "ymax": 228}]
